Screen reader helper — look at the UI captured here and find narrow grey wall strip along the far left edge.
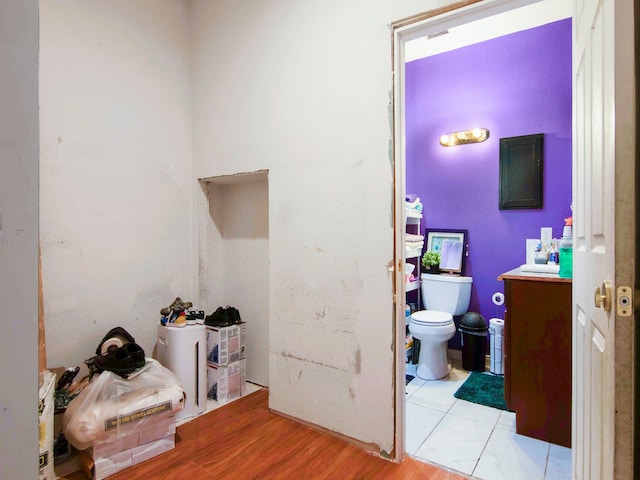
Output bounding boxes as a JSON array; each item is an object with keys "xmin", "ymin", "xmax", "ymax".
[{"xmin": 0, "ymin": 0, "xmax": 39, "ymax": 479}]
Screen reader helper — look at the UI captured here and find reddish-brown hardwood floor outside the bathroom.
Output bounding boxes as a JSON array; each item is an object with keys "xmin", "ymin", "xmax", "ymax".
[{"xmin": 67, "ymin": 389, "xmax": 467, "ymax": 480}]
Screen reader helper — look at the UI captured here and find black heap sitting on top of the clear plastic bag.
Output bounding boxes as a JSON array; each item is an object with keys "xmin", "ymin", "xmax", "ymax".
[{"xmin": 84, "ymin": 327, "xmax": 146, "ymax": 378}]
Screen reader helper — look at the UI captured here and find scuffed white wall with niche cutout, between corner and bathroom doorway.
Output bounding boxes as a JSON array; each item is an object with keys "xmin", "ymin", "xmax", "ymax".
[{"xmin": 192, "ymin": 0, "xmax": 447, "ymax": 452}]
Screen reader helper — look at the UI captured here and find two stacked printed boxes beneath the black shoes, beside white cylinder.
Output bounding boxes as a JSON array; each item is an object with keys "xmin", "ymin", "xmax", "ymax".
[{"xmin": 207, "ymin": 323, "xmax": 247, "ymax": 403}]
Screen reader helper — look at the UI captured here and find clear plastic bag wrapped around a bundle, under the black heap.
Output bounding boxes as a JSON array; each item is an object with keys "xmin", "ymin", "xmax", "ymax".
[{"xmin": 62, "ymin": 358, "xmax": 185, "ymax": 450}]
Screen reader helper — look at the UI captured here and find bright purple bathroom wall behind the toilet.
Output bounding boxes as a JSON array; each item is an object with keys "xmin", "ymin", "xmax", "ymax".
[{"xmin": 406, "ymin": 19, "xmax": 571, "ymax": 348}]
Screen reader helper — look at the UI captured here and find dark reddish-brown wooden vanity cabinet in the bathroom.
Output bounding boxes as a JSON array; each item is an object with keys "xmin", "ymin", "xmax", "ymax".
[{"xmin": 498, "ymin": 269, "xmax": 571, "ymax": 447}]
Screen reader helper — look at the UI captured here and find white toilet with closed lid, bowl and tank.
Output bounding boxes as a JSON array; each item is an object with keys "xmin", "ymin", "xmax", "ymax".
[{"xmin": 409, "ymin": 273, "xmax": 473, "ymax": 380}]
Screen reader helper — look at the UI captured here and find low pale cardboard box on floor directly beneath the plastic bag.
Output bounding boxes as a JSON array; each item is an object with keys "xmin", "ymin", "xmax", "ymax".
[{"xmin": 78, "ymin": 433, "xmax": 176, "ymax": 480}]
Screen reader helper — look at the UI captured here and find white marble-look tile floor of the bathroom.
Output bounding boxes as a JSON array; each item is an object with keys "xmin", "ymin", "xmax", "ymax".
[{"xmin": 405, "ymin": 365, "xmax": 571, "ymax": 480}]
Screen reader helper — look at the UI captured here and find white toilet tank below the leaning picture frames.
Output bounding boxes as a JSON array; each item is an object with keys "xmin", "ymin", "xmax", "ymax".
[{"xmin": 420, "ymin": 273, "xmax": 473, "ymax": 315}]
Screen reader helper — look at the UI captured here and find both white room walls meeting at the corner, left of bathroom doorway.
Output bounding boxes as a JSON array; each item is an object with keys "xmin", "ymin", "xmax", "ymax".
[{"xmin": 35, "ymin": 0, "xmax": 476, "ymax": 460}]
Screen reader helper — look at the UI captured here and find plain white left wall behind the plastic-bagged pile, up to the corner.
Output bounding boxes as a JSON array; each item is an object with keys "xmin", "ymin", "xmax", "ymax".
[{"xmin": 40, "ymin": 0, "xmax": 197, "ymax": 367}]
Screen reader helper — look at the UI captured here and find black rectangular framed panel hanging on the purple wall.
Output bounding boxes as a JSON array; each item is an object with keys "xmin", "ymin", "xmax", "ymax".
[{"xmin": 499, "ymin": 133, "xmax": 544, "ymax": 210}]
